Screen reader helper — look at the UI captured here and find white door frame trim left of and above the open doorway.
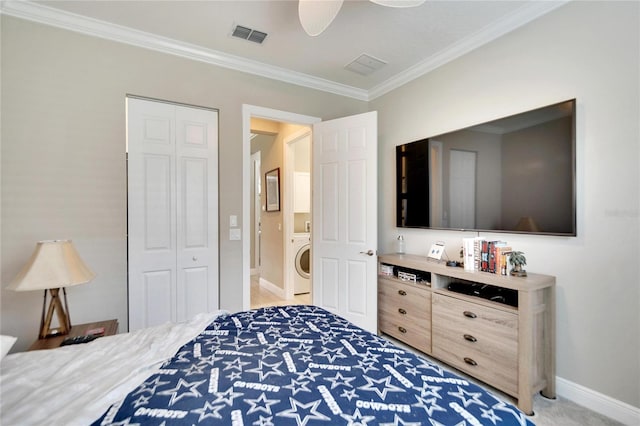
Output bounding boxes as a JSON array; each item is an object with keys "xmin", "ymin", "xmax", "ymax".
[{"xmin": 242, "ymin": 104, "xmax": 322, "ymax": 310}]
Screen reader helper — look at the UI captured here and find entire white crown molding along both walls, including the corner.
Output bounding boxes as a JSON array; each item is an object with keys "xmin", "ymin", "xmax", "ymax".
[{"xmin": 0, "ymin": 0, "xmax": 571, "ymax": 101}]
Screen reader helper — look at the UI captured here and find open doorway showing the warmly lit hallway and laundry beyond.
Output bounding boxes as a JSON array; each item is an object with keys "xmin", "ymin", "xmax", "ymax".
[{"xmin": 245, "ymin": 110, "xmax": 311, "ymax": 308}]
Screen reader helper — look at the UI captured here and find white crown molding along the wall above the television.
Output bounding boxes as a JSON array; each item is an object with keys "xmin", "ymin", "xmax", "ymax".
[{"xmin": 369, "ymin": 0, "xmax": 571, "ymax": 101}]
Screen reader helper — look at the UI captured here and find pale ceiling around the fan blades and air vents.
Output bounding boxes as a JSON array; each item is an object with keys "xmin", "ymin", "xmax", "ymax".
[{"xmin": 2, "ymin": 0, "xmax": 566, "ymax": 100}]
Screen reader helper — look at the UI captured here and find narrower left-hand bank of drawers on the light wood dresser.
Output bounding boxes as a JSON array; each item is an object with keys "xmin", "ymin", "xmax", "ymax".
[{"xmin": 378, "ymin": 279, "xmax": 431, "ymax": 354}]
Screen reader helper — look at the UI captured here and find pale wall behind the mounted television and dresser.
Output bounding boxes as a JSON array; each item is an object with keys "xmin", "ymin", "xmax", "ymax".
[{"xmin": 371, "ymin": 2, "xmax": 640, "ymax": 407}]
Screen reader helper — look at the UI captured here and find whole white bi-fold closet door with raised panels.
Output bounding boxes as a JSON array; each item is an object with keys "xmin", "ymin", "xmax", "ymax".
[{"xmin": 127, "ymin": 97, "xmax": 219, "ymax": 331}]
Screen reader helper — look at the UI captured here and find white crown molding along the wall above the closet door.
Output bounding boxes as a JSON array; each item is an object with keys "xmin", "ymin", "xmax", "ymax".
[{"xmin": 0, "ymin": 1, "xmax": 369, "ymax": 101}]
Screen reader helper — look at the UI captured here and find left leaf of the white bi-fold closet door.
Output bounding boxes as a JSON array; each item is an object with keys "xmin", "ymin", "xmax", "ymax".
[{"xmin": 127, "ymin": 99, "xmax": 176, "ymax": 330}]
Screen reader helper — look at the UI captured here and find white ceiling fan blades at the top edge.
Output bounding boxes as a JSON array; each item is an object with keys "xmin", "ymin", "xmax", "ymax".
[{"xmin": 298, "ymin": 0, "xmax": 425, "ymax": 36}]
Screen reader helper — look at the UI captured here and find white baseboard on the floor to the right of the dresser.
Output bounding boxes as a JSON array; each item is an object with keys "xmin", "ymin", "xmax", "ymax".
[{"xmin": 556, "ymin": 377, "xmax": 640, "ymax": 425}]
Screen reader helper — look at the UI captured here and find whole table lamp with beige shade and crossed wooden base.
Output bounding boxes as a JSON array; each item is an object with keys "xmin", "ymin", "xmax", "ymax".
[{"xmin": 7, "ymin": 240, "xmax": 95, "ymax": 339}]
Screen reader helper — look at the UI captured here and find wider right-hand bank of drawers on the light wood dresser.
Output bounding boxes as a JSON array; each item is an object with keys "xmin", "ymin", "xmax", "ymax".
[{"xmin": 432, "ymin": 294, "xmax": 518, "ymax": 395}]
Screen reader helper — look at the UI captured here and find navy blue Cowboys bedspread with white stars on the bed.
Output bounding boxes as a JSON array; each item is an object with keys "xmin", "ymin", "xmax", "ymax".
[{"xmin": 94, "ymin": 306, "xmax": 532, "ymax": 425}]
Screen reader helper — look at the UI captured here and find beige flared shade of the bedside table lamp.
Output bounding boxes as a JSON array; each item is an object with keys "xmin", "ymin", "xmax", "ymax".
[{"xmin": 7, "ymin": 240, "xmax": 95, "ymax": 291}]
